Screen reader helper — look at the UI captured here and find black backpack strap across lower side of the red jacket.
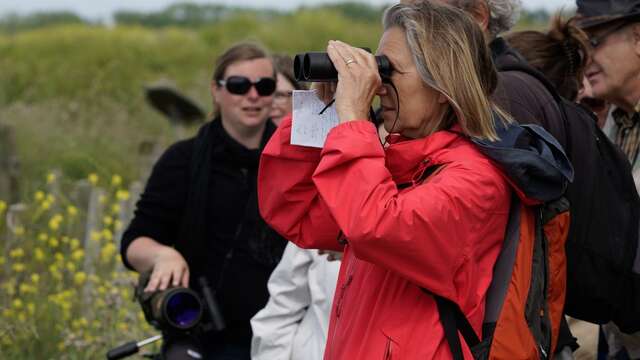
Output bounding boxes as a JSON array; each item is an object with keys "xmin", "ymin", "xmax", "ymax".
[{"xmin": 420, "ymin": 288, "xmax": 480, "ymax": 360}]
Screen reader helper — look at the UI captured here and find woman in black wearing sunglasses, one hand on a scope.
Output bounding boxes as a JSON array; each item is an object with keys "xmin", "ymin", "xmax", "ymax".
[{"xmin": 121, "ymin": 43, "xmax": 286, "ymax": 359}]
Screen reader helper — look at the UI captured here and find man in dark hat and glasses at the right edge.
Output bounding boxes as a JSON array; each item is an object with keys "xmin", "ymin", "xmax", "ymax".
[{"xmin": 577, "ymin": 0, "xmax": 640, "ymax": 359}]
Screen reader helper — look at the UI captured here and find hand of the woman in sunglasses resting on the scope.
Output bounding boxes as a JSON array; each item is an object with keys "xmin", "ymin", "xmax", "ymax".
[{"xmin": 144, "ymin": 246, "xmax": 189, "ymax": 292}]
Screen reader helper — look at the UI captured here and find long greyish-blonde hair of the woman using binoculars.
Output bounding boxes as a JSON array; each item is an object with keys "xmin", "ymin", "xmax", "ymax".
[{"xmin": 383, "ymin": 1, "xmax": 508, "ymax": 140}]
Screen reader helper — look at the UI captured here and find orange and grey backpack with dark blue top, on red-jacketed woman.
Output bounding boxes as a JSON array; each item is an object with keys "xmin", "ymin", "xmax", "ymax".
[{"xmin": 423, "ymin": 125, "xmax": 573, "ymax": 360}]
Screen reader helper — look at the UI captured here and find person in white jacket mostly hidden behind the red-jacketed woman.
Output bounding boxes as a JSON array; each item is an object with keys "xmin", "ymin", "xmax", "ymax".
[{"xmin": 251, "ymin": 55, "xmax": 341, "ymax": 360}]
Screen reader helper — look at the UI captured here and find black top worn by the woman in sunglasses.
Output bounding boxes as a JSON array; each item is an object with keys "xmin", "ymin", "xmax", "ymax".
[{"xmin": 120, "ymin": 120, "xmax": 286, "ymax": 346}]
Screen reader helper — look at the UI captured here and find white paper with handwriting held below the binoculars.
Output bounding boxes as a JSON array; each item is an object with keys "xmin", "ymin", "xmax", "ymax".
[{"xmin": 291, "ymin": 90, "xmax": 340, "ymax": 148}]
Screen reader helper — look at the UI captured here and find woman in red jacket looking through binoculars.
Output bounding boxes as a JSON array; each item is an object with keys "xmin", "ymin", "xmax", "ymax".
[{"xmin": 258, "ymin": 2, "xmax": 511, "ymax": 359}]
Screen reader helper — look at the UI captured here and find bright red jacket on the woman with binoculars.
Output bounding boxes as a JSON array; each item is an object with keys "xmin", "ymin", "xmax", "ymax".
[{"xmin": 258, "ymin": 119, "xmax": 511, "ymax": 360}]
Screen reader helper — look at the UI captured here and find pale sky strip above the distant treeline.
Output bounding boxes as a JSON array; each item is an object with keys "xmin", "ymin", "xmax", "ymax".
[{"xmin": 0, "ymin": 0, "xmax": 575, "ymax": 19}]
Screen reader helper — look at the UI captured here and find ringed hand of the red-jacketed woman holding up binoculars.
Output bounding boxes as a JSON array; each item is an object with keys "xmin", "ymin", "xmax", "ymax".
[{"xmin": 327, "ymin": 40, "xmax": 382, "ymax": 123}]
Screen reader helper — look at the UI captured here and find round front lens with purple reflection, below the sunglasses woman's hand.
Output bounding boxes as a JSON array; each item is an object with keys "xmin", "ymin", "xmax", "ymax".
[{"xmin": 151, "ymin": 287, "xmax": 202, "ymax": 331}]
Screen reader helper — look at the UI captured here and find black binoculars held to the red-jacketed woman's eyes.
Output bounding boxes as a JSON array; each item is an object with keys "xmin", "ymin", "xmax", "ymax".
[{"xmin": 293, "ymin": 52, "xmax": 392, "ymax": 82}]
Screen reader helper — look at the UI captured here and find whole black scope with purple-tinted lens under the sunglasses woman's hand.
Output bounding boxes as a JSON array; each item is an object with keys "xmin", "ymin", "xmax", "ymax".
[{"xmin": 135, "ymin": 272, "xmax": 225, "ymax": 335}]
